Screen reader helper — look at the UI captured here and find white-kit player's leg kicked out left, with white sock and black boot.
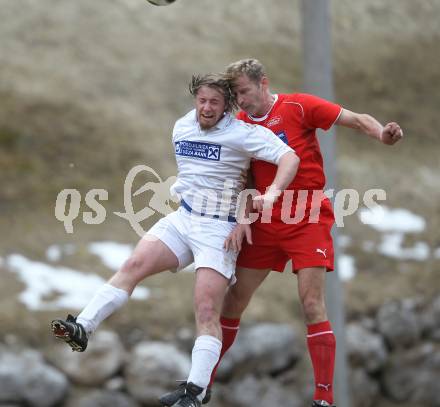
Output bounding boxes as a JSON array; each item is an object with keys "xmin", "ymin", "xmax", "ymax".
[{"xmin": 51, "ymin": 235, "xmax": 178, "ymax": 352}]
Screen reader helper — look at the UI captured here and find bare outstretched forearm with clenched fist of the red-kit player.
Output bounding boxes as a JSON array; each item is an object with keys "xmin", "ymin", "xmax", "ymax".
[{"xmin": 335, "ymin": 109, "xmax": 403, "ymax": 145}]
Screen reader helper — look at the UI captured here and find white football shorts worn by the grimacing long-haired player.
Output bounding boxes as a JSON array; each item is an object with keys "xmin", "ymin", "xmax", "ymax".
[{"xmin": 147, "ymin": 207, "xmax": 238, "ymax": 284}]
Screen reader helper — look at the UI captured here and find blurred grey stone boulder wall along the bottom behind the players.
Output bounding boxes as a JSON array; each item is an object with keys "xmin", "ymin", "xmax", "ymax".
[{"xmin": 0, "ymin": 297, "xmax": 440, "ymax": 407}]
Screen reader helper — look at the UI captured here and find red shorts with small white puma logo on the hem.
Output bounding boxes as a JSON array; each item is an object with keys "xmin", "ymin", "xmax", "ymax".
[{"xmin": 237, "ymin": 203, "xmax": 334, "ymax": 272}]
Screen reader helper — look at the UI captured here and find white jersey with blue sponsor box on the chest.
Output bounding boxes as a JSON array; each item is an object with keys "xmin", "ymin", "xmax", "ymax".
[{"xmin": 171, "ymin": 109, "xmax": 293, "ymax": 218}]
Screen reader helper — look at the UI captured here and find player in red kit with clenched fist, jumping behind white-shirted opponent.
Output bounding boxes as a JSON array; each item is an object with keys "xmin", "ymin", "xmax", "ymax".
[{"xmin": 160, "ymin": 59, "xmax": 403, "ymax": 407}]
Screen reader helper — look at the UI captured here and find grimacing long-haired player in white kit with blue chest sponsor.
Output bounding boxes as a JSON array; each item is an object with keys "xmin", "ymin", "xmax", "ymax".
[{"xmin": 51, "ymin": 75, "xmax": 299, "ymax": 407}]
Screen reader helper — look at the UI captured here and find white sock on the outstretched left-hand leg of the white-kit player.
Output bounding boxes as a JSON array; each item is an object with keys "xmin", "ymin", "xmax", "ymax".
[{"xmin": 76, "ymin": 284, "xmax": 129, "ymax": 336}]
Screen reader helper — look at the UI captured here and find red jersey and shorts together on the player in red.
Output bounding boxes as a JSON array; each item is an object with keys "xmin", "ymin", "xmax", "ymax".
[{"xmin": 237, "ymin": 93, "xmax": 342, "ymax": 272}]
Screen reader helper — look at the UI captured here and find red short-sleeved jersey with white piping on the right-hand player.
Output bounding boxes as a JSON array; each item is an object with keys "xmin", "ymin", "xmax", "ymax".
[{"xmin": 237, "ymin": 93, "xmax": 342, "ymax": 218}]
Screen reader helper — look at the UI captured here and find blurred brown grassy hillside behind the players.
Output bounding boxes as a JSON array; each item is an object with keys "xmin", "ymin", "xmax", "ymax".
[{"xmin": 0, "ymin": 0, "xmax": 440, "ymax": 350}]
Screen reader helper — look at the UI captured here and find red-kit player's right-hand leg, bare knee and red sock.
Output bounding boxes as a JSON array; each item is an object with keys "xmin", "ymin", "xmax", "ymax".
[{"xmin": 297, "ymin": 267, "xmax": 336, "ymax": 406}]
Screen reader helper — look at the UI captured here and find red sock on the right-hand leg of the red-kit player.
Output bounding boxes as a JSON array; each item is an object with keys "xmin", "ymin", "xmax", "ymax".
[{"xmin": 307, "ymin": 321, "xmax": 336, "ymax": 404}]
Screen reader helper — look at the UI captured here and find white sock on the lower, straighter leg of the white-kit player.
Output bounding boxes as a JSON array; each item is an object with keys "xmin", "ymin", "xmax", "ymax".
[{"xmin": 187, "ymin": 335, "xmax": 222, "ymax": 399}]
